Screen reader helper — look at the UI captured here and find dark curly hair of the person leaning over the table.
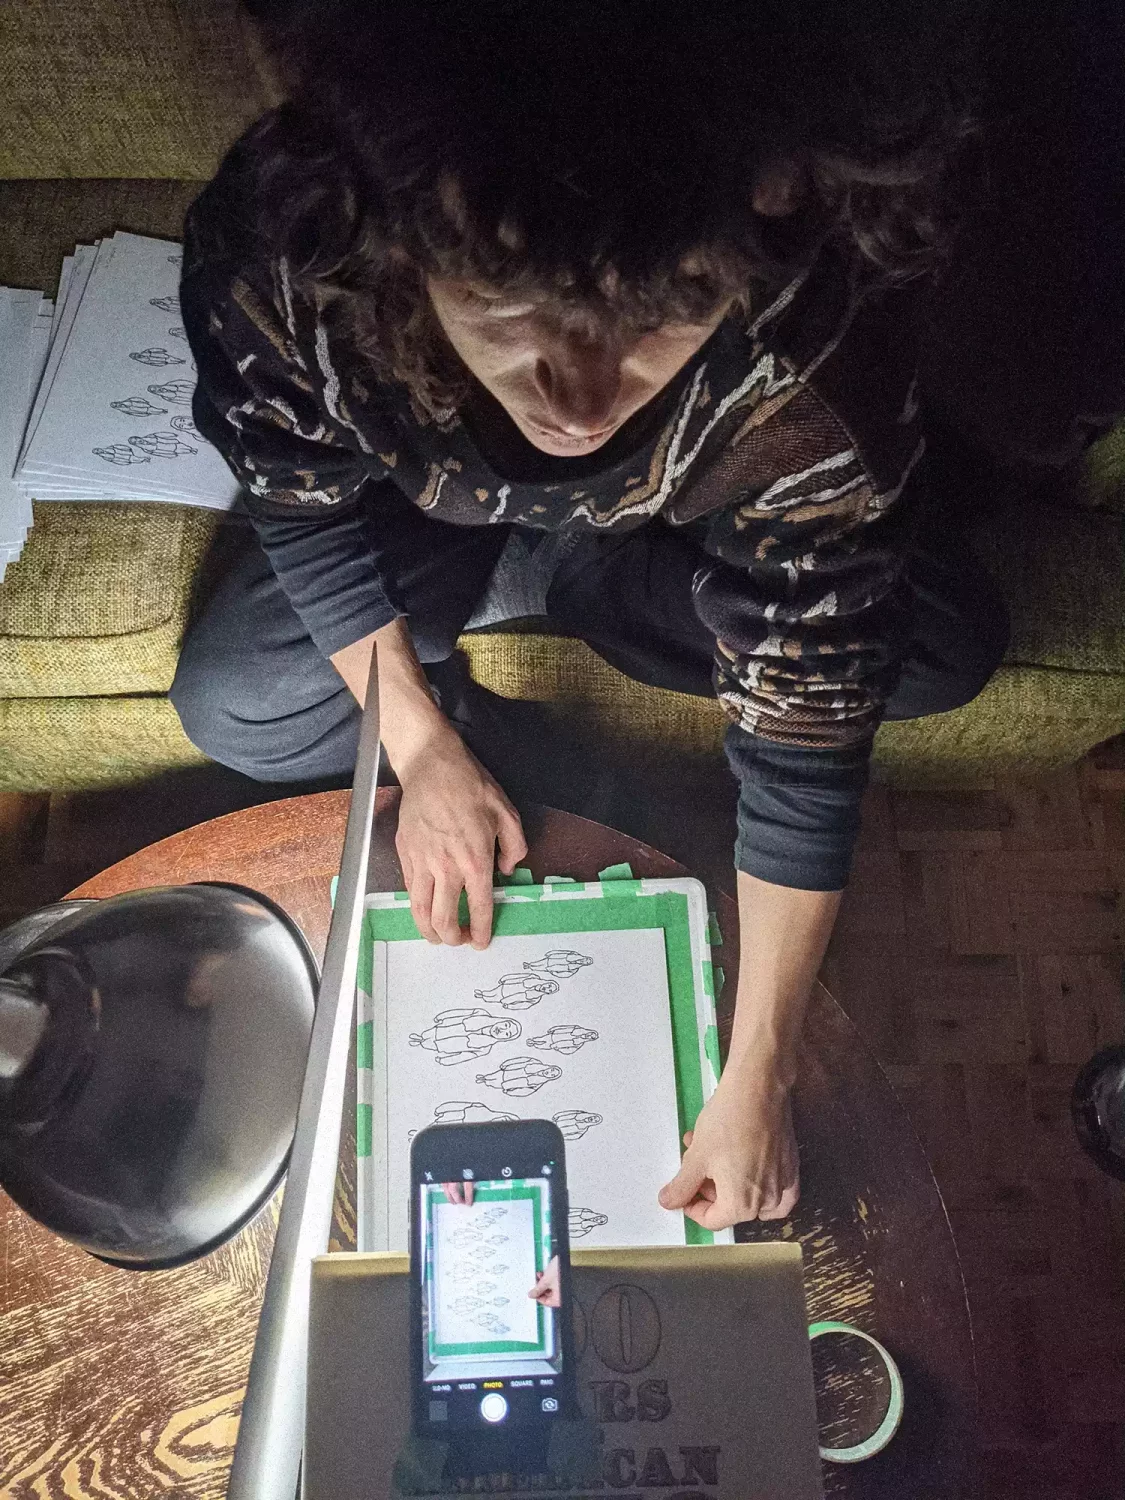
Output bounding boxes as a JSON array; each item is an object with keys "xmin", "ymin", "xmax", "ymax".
[{"xmin": 249, "ymin": 0, "xmax": 974, "ymax": 414}]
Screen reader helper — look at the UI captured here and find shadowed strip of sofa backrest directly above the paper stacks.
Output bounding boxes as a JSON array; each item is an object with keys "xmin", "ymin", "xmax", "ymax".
[{"xmin": 0, "ymin": 179, "xmax": 203, "ymax": 297}]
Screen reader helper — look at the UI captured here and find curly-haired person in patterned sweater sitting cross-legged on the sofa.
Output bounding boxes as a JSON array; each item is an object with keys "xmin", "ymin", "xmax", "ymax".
[{"xmin": 173, "ymin": 0, "xmax": 1005, "ymax": 1229}]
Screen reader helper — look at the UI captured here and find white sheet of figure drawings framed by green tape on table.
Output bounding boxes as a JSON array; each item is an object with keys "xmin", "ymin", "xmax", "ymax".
[{"xmin": 372, "ymin": 929, "xmax": 684, "ymax": 1251}]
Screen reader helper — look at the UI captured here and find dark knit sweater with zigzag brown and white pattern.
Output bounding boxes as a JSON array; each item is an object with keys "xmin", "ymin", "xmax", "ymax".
[{"xmin": 182, "ymin": 117, "xmax": 924, "ymax": 890}]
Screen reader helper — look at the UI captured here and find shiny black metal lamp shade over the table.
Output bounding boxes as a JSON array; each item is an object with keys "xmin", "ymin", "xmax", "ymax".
[{"xmin": 0, "ymin": 885, "xmax": 317, "ymax": 1269}]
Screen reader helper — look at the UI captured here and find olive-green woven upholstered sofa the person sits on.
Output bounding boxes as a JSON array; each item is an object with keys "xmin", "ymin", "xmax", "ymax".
[{"xmin": 0, "ymin": 0, "xmax": 1125, "ymax": 791}]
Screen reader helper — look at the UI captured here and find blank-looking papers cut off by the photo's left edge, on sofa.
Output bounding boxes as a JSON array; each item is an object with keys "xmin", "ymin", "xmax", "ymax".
[{"xmin": 0, "ymin": 287, "xmax": 54, "ymax": 579}]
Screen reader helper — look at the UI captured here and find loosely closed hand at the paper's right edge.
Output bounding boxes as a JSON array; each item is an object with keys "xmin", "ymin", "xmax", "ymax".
[{"xmin": 660, "ymin": 1074, "xmax": 801, "ymax": 1230}]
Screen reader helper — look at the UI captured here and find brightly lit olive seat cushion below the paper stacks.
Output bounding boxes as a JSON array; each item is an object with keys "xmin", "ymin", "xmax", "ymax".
[{"xmin": 0, "ymin": 503, "xmax": 218, "ymax": 699}]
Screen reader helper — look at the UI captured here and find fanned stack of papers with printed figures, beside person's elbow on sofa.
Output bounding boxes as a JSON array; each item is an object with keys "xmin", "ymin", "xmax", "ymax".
[{"xmin": 8, "ymin": 233, "xmax": 239, "ymax": 522}]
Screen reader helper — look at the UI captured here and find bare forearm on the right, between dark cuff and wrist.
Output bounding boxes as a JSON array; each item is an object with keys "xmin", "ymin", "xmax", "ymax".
[{"xmin": 726, "ymin": 870, "xmax": 842, "ymax": 1089}]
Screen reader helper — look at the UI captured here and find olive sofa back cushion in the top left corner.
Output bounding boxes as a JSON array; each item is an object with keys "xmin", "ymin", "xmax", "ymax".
[{"xmin": 0, "ymin": 0, "xmax": 267, "ymax": 179}]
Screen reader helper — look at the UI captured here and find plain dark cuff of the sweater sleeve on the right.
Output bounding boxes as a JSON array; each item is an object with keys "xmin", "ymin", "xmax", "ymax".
[{"xmin": 726, "ymin": 726, "xmax": 870, "ymax": 891}]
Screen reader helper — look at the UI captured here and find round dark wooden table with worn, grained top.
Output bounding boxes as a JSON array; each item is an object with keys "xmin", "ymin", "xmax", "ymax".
[{"xmin": 0, "ymin": 791, "xmax": 977, "ymax": 1500}]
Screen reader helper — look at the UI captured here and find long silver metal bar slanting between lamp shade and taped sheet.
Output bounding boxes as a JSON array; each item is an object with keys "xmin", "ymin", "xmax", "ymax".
[{"xmin": 227, "ymin": 651, "xmax": 380, "ymax": 1500}]
